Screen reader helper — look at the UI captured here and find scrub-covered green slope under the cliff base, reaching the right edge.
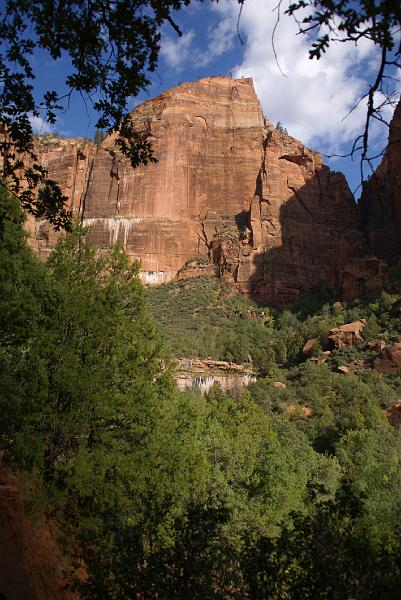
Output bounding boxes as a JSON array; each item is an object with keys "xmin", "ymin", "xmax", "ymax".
[{"xmin": 148, "ymin": 272, "xmax": 401, "ymax": 374}]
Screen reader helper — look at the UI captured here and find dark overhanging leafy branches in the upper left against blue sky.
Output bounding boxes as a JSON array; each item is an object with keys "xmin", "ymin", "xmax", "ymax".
[{"xmin": 0, "ymin": 0, "xmax": 190, "ymax": 228}]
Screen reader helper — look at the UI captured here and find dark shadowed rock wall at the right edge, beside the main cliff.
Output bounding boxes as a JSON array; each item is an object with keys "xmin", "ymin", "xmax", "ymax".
[{"xmin": 360, "ymin": 100, "xmax": 401, "ymax": 264}]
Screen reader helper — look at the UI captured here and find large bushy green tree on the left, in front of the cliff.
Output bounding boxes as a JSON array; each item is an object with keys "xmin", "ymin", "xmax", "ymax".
[{"xmin": 0, "ymin": 192, "xmax": 172, "ymax": 507}]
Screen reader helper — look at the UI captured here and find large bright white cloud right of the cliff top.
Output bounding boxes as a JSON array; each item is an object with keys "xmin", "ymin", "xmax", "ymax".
[{"xmin": 208, "ymin": 0, "xmax": 391, "ymax": 153}]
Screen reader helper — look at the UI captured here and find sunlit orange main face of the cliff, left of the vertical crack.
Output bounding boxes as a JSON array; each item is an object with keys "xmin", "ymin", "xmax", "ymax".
[{"xmin": 85, "ymin": 77, "xmax": 271, "ymax": 283}]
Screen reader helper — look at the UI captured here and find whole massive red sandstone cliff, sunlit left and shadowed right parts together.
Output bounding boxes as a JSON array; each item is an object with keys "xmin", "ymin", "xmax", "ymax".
[{"xmin": 28, "ymin": 77, "xmax": 380, "ymax": 306}]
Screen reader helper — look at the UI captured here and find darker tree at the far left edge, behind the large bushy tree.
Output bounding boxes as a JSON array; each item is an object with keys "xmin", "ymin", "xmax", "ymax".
[{"xmin": 0, "ymin": 187, "xmax": 56, "ymax": 464}]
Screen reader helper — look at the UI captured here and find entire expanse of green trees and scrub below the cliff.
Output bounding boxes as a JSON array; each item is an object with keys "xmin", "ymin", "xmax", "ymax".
[{"xmin": 0, "ymin": 186, "xmax": 401, "ymax": 600}]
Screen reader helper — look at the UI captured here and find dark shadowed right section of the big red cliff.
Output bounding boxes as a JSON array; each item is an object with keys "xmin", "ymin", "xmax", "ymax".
[{"xmin": 236, "ymin": 161, "xmax": 366, "ymax": 310}]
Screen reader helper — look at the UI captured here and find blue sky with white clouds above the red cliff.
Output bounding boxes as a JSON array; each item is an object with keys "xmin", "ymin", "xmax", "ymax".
[{"xmin": 29, "ymin": 0, "xmax": 398, "ymax": 197}]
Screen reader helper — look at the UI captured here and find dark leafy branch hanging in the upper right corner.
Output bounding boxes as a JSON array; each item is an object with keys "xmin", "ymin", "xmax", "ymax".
[{"xmin": 277, "ymin": 0, "xmax": 401, "ymax": 176}]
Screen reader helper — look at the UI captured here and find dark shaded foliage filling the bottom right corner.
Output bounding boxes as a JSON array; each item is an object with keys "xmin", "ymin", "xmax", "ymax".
[{"xmin": 242, "ymin": 482, "xmax": 401, "ymax": 600}]
